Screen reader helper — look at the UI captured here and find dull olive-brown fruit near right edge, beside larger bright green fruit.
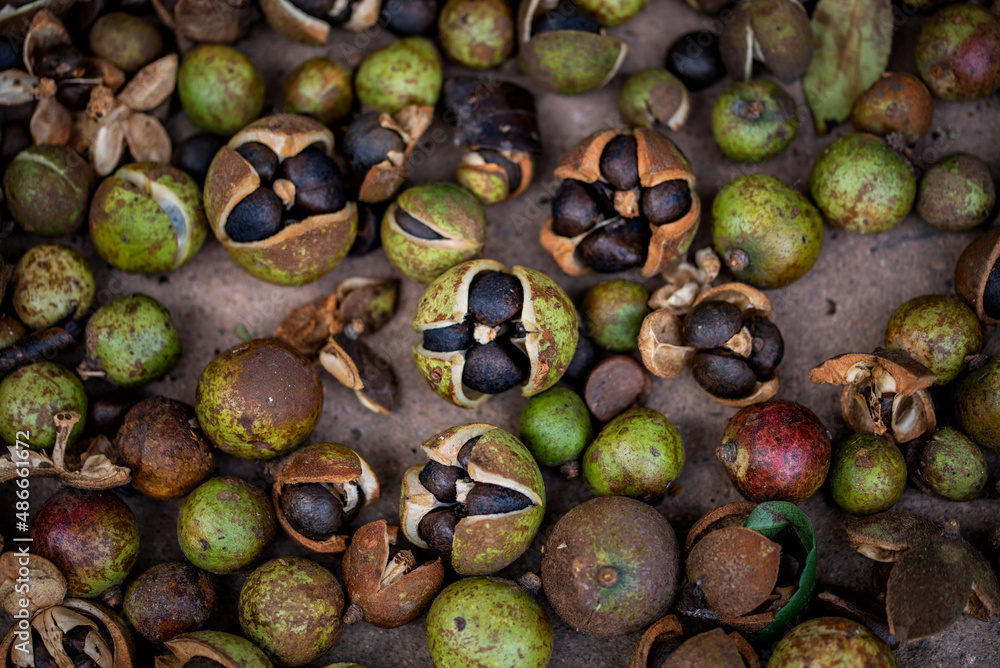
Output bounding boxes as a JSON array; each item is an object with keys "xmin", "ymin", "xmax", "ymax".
[{"xmin": 917, "ymin": 153, "xmax": 997, "ymax": 232}]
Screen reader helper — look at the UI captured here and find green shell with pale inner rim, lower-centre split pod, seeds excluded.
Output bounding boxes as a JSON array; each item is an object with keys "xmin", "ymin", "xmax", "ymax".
[{"xmin": 399, "ymin": 424, "xmax": 545, "ymax": 575}]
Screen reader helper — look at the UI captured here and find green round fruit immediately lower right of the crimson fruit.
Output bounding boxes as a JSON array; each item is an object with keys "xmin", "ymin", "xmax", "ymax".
[{"xmin": 828, "ymin": 434, "xmax": 906, "ymax": 515}]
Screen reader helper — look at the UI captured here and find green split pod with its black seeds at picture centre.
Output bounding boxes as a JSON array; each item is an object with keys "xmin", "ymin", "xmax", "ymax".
[{"xmin": 413, "ymin": 260, "xmax": 579, "ymax": 408}]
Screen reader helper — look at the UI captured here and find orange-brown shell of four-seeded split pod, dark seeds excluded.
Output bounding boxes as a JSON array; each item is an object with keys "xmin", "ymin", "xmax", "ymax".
[{"xmin": 539, "ymin": 128, "xmax": 701, "ymax": 277}]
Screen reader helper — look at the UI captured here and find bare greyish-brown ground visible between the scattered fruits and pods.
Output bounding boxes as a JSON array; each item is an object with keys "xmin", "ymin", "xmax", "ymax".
[{"xmin": 0, "ymin": 0, "xmax": 1000, "ymax": 668}]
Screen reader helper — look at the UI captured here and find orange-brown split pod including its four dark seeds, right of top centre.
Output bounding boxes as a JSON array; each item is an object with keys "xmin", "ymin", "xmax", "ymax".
[{"xmin": 540, "ymin": 128, "xmax": 701, "ymax": 276}]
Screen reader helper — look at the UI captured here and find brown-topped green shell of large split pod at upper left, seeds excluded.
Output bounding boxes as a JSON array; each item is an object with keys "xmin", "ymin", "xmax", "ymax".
[{"xmin": 204, "ymin": 114, "xmax": 358, "ymax": 285}]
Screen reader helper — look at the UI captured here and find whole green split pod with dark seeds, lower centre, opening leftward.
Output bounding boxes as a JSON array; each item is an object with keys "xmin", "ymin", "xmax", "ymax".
[{"xmin": 399, "ymin": 424, "xmax": 545, "ymax": 575}]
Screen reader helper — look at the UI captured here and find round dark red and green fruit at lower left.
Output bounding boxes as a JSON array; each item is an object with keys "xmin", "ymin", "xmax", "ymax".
[{"xmin": 31, "ymin": 487, "xmax": 139, "ymax": 598}]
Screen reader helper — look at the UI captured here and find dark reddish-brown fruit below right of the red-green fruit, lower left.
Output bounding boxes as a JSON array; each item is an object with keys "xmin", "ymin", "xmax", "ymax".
[{"xmin": 122, "ymin": 561, "xmax": 216, "ymax": 643}]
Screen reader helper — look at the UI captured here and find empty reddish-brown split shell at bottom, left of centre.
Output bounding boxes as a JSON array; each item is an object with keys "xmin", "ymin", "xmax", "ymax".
[{"xmin": 342, "ymin": 520, "xmax": 444, "ymax": 629}]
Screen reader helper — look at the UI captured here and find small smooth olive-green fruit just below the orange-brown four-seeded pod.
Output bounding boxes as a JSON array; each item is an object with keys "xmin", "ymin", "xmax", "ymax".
[{"xmin": 583, "ymin": 279, "xmax": 649, "ymax": 353}]
